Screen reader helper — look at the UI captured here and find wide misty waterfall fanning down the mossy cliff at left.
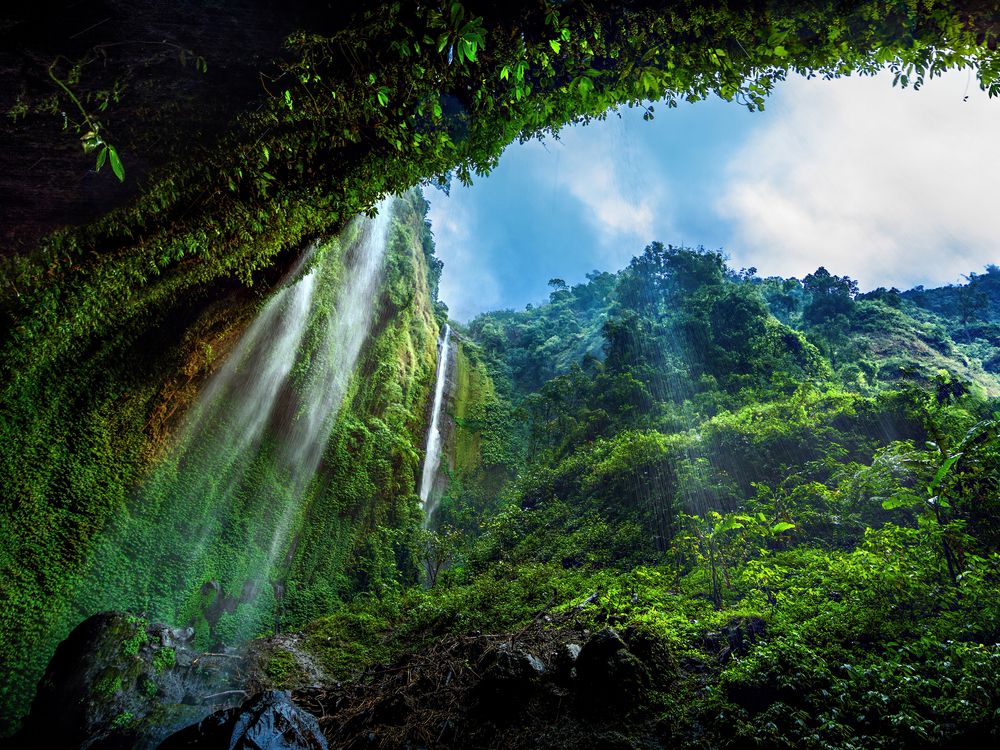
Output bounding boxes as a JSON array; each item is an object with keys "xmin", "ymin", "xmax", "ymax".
[{"xmin": 74, "ymin": 201, "xmax": 391, "ymax": 642}]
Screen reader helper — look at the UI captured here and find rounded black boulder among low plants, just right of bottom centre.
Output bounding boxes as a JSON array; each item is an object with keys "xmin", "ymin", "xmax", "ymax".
[{"xmin": 576, "ymin": 628, "xmax": 650, "ymax": 712}]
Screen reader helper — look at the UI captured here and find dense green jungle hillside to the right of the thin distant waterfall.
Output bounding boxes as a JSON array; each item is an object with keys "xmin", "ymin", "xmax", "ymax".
[{"xmin": 256, "ymin": 248, "xmax": 1000, "ymax": 748}]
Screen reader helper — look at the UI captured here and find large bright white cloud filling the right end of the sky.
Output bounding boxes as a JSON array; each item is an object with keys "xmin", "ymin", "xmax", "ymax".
[{"xmin": 716, "ymin": 73, "xmax": 1000, "ymax": 287}]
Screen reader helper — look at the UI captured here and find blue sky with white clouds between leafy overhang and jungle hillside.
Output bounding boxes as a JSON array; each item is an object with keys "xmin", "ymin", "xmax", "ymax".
[{"xmin": 425, "ymin": 71, "xmax": 1000, "ymax": 321}]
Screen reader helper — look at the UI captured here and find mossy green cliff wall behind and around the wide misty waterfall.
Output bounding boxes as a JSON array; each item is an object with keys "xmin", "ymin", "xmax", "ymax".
[{"xmin": 0, "ymin": 194, "xmax": 439, "ymax": 729}]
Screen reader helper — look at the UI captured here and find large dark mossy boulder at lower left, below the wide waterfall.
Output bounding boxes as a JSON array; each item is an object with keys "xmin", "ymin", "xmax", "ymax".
[{"xmin": 13, "ymin": 612, "xmax": 244, "ymax": 750}]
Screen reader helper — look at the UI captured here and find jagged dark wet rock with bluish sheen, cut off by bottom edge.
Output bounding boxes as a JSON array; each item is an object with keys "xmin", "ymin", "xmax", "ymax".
[{"xmin": 160, "ymin": 690, "xmax": 328, "ymax": 750}]
